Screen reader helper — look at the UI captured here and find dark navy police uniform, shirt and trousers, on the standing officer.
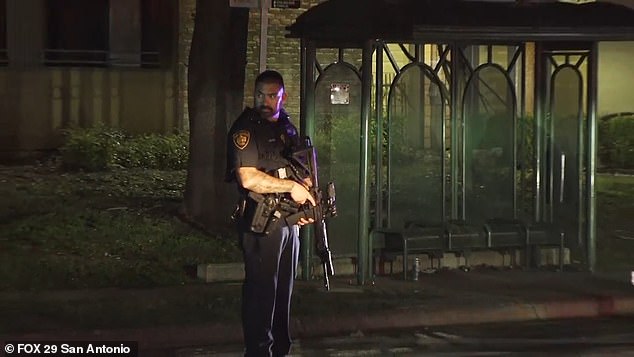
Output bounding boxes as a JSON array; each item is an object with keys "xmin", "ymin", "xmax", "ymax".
[{"xmin": 227, "ymin": 108, "xmax": 299, "ymax": 356}]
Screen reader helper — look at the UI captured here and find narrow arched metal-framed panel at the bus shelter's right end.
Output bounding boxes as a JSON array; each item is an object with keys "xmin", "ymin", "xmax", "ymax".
[{"xmin": 544, "ymin": 51, "xmax": 588, "ymax": 260}]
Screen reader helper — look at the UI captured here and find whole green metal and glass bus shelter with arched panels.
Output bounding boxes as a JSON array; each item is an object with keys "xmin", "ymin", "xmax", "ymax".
[{"xmin": 288, "ymin": 0, "xmax": 634, "ymax": 284}]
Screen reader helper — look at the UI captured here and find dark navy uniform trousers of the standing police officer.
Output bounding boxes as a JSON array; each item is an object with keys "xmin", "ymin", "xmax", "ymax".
[{"xmin": 240, "ymin": 225, "xmax": 299, "ymax": 356}]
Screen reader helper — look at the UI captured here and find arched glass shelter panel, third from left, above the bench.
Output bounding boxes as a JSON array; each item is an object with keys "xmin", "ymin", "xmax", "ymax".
[{"xmin": 464, "ymin": 66, "xmax": 516, "ymax": 224}]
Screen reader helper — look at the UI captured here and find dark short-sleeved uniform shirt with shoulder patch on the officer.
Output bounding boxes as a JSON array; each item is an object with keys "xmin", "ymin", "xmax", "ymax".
[{"xmin": 225, "ymin": 108, "xmax": 299, "ymax": 182}]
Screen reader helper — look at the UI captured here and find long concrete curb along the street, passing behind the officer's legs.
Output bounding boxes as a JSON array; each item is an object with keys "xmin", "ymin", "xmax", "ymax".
[{"xmin": 0, "ymin": 296, "xmax": 634, "ymax": 350}]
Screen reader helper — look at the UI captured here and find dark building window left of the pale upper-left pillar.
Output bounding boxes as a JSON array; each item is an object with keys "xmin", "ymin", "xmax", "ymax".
[{"xmin": 44, "ymin": 0, "xmax": 109, "ymax": 66}]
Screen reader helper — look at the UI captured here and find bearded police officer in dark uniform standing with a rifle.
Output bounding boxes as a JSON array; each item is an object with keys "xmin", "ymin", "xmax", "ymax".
[{"xmin": 227, "ymin": 70, "xmax": 315, "ymax": 356}]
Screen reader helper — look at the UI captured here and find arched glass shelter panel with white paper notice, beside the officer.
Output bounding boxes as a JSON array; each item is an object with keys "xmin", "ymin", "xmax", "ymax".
[{"xmin": 314, "ymin": 63, "xmax": 361, "ymax": 256}]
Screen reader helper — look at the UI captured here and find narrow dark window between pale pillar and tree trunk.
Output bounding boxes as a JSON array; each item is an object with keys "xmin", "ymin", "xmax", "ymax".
[{"xmin": 141, "ymin": 0, "xmax": 178, "ymax": 67}]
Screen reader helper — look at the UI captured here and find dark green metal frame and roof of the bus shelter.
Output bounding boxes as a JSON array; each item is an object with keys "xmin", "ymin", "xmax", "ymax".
[{"xmin": 288, "ymin": 0, "xmax": 634, "ymax": 284}]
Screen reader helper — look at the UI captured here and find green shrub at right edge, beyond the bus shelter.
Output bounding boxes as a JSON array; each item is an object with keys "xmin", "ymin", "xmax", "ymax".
[{"xmin": 599, "ymin": 113, "xmax": 634, "ymax": 169}]
